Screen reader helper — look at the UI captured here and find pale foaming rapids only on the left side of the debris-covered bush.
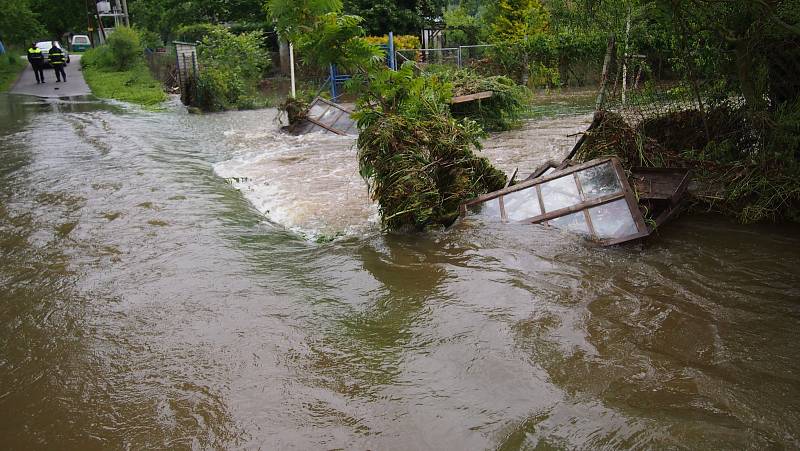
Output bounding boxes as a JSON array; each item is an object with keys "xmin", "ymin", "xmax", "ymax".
[{"xmin": 214, "ymin": 125, "xmax": 378, "ymax": 239}]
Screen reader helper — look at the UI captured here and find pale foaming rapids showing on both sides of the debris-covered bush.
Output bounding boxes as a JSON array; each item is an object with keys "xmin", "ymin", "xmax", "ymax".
[{"xmin": 214, "ymin": 110, "xmax": 591, "ymax": 240}]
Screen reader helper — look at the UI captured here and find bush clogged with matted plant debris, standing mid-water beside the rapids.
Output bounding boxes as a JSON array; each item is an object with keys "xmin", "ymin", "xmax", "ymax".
[{"xmin": 355, "ymin": 63, "xmax": 506, "ymax": 231}]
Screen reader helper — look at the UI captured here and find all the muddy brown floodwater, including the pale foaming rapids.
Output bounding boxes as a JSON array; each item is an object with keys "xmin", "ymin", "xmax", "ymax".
[{"xmin": 0, "ymin": 96, "xmax": 800, "ymax": 450}]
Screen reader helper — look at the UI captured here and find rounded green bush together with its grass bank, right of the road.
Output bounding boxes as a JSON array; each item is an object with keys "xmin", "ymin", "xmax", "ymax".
[{"xmin": 81, "ymin": 27, "xmax": 167, "ymax": 107}]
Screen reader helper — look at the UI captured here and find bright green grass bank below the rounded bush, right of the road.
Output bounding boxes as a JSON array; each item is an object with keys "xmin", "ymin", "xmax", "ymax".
[{"xmin": 81, "ymin": 47, "xmax": 168, "ymax": 109}]
